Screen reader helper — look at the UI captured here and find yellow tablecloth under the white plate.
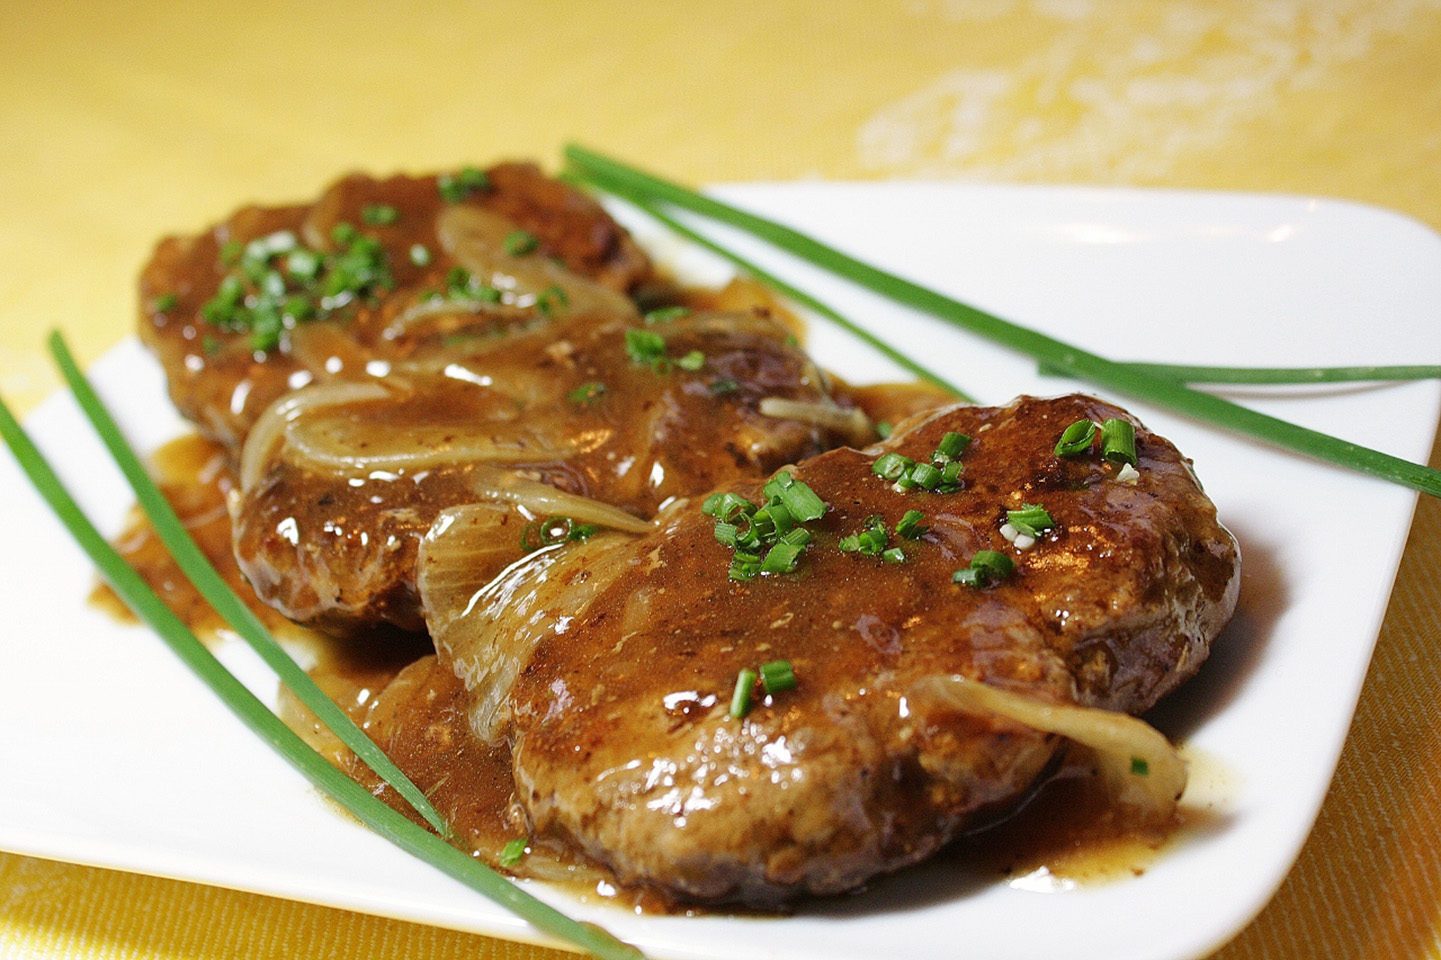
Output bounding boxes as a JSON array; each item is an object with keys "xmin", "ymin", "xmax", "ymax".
[{"xmin": 0, "ymin": 0, "xmax": 1441, "ymax": 960}]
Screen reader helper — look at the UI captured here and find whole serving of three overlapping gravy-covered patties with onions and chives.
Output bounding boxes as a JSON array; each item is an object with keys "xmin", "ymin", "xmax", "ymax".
[{"xmin": 132, "ymin": 164, "xmax": 1239, "ymax": 907}]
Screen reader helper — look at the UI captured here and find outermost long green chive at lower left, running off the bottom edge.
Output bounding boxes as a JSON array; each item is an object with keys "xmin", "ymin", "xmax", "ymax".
[{"xmin": 0, "ymin": 367, "xmax": 643, "ymax": 960}]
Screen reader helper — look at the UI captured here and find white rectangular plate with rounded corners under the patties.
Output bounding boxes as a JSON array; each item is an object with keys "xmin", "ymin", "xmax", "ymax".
[{"xmin": 0, "ymin": 183, "xmax": 1441, "ymax": 960}]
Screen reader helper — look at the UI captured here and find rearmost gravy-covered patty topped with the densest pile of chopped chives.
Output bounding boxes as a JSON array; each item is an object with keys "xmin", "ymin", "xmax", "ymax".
[{"xmin": 140, "ymin": 163, "xmax": 653, "ymax": 454}]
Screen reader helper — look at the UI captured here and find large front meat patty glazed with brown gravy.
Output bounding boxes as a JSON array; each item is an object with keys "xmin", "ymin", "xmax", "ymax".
[{"xmin": 421, "ymin": 395, "xmax": 1239, "ymax": 904}]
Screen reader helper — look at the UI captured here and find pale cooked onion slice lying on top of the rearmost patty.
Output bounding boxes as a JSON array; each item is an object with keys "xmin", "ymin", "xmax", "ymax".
[{"xmin": 435, "ymin": 205, "xmax": 635, "ymax": 317}]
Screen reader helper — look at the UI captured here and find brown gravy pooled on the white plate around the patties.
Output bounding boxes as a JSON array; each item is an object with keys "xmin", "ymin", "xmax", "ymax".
[{"xmin": 94, "ymin": 423, "xmax": 1215, "ymax": 912}]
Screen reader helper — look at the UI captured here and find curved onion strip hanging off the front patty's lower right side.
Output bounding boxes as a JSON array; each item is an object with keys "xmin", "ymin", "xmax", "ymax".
[{"xmin": 912, "ymin": 676, "xmax": 1186, "ymax": 820}]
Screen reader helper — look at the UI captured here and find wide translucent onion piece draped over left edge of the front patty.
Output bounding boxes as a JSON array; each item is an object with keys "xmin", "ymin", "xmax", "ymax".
[{"xmin": 416, "ymin": 505, "xmax": 627, "ymax": 744}]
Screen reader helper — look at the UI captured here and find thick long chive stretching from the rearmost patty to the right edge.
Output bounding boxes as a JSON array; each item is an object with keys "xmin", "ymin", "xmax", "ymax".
[{"xmin": 565, "ymin": 144, "xmax": 1441, "ymax": 496}]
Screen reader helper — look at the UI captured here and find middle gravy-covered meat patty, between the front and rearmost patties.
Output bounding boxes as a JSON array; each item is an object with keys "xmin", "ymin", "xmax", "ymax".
[{"xmin": 232, "ymin": 313, "xmax": 840, "ymax": 634}]
